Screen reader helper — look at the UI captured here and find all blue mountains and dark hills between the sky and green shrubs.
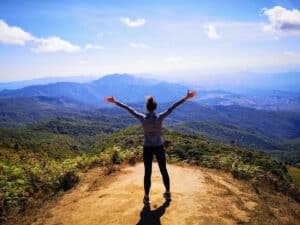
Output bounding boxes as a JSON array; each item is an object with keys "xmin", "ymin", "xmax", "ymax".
[{"xmin": 0, "ymin": 74, "xmax": 300, "ymax": 164}]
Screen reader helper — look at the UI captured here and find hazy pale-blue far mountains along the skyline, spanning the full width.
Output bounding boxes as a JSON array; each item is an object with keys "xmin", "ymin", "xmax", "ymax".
[{"xmin": 0, "ymin": 74, "xmax": 300, "ymax": 112}]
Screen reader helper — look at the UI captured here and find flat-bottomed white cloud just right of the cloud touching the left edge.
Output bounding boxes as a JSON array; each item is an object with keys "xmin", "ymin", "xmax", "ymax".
[{"xmin": 32, "ymin": 37, "xmax": 80, "ymax": 52}]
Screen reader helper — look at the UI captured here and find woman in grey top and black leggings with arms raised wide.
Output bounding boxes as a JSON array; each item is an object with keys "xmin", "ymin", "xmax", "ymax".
[{"xmin": 104, "ymin": 91, "xmax": 196, "ymax": 204}]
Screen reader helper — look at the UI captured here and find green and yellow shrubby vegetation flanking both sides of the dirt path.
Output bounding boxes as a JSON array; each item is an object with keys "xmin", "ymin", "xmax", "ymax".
[{"xmin": 0, "ymin": 125, "xmax": 299, "ymax": 222}]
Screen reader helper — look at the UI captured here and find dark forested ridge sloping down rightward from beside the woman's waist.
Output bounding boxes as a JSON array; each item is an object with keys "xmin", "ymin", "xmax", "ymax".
[{"xmin": 168, "ymin": 121, "xmax": 300, "ymax": 165}]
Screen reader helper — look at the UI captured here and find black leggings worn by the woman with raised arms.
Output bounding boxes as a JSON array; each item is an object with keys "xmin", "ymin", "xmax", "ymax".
[{"xmin": 143, "ymin": 145, "xmax": 170, "ymax": 195}]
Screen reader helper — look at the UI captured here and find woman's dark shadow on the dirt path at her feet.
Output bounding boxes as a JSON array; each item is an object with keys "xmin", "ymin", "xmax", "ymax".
[{"xmin": 136, "ymin": 201, "xmax": 170, "ymax": 225}]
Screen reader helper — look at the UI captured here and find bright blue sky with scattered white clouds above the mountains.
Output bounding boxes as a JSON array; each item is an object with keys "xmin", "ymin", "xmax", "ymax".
[{"xmin": 0, "ymin": 0, "xmax": 300, "ymax": 82}]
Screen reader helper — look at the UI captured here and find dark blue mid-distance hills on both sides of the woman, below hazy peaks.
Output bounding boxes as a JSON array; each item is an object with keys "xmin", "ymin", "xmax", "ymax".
[{"xmin": 0, "ymin": 96, "xmax": 300, "ymax": 165}]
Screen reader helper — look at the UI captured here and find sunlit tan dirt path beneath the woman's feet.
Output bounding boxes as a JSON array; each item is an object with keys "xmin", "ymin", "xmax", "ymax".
[{"xmin": 33, "ymin": 163, "xmax": 264, "ymax": 225}]
